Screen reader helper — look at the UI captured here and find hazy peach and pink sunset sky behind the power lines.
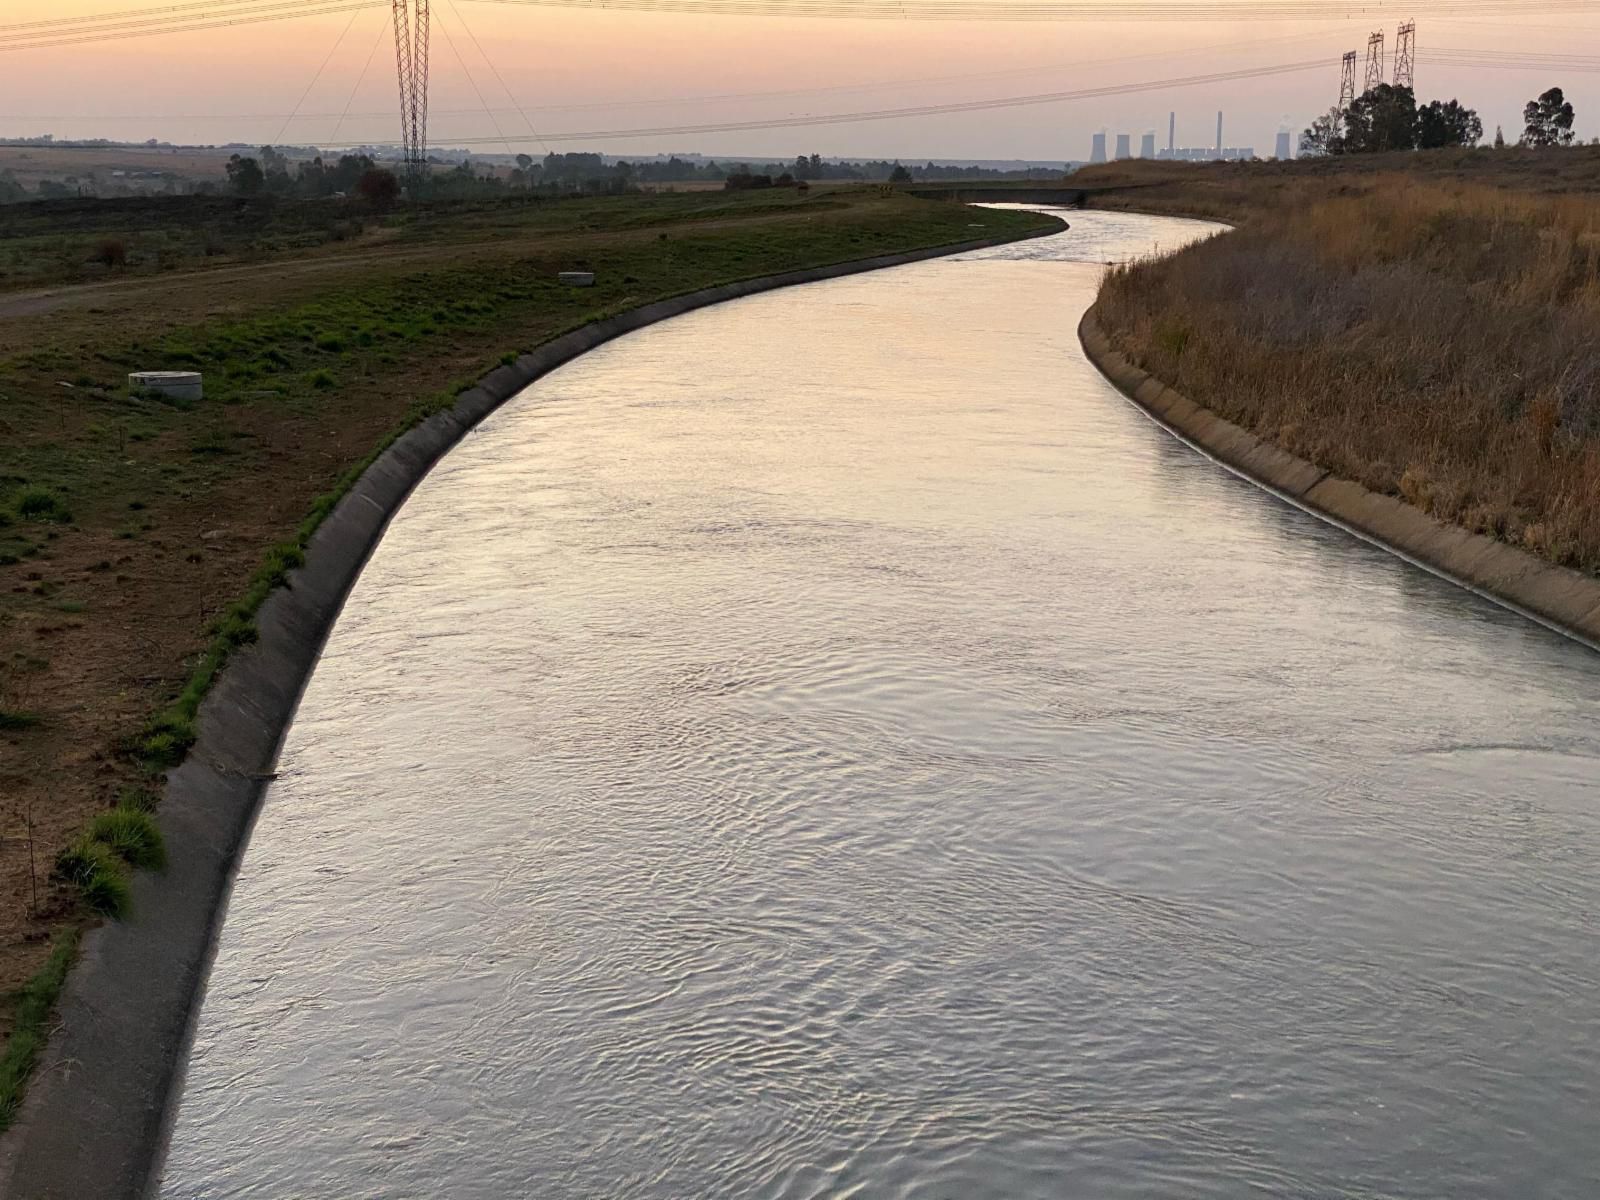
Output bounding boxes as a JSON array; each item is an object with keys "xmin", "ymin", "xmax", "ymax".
[{"xmin": 0, "ymin": 0, "xmax": 1600, "ymax": 162}]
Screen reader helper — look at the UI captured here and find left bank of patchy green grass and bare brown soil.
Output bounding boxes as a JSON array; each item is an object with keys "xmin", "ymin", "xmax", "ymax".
[{"xmin": 0, "ymin": 180, "xmax": 1051, "ymax": 1128}]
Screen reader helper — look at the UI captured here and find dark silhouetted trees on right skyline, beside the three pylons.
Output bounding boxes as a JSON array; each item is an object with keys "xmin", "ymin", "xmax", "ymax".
[{"xmin": 1301, "ymin": 83, "xmax": 1574, "ymax": 157}]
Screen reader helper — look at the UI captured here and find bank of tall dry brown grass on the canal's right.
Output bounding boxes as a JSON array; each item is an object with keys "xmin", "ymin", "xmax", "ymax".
[{"xmin": 1085, "ymin": 149, "xmax": 1600, "ymax": 573}]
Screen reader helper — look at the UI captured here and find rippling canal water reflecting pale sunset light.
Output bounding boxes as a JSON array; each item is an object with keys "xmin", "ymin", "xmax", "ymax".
[{"xmin": 162, "ymin": 213, "xmax": 1600, "ymax": 1200}]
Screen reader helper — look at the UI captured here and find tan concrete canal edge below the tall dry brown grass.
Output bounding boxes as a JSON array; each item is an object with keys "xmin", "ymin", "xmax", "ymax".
[{"xmin": 1078, "ymin": 306, "xmax": 1600, "ymax": 650}]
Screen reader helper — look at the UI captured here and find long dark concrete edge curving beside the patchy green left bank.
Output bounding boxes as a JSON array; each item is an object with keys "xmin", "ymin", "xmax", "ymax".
[{"xmin": 0, "ymin": 222, "xmax": 1066, "ymax": 1200}]
